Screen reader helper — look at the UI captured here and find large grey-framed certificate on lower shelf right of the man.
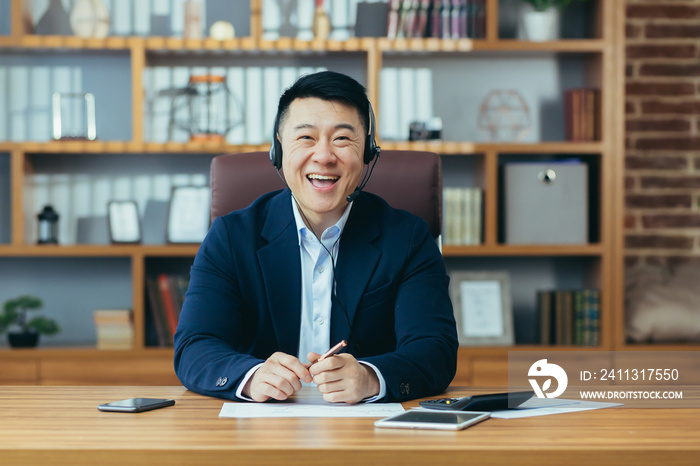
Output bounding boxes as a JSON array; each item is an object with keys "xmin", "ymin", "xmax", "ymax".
[{"xmin": 450, "ymin": 272, "xmax": 515, "ymax": 345}]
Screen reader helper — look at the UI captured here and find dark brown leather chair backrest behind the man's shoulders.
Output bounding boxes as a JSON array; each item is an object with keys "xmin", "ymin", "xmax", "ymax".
[{"xmin": 211, "ymin": 150, "xmax": 442, "ymax": 238}]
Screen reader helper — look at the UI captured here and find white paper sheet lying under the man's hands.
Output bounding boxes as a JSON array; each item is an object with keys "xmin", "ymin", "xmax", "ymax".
[{"xmin": 219, "ymin": 387, "xmax": 405, "ymax": 418}]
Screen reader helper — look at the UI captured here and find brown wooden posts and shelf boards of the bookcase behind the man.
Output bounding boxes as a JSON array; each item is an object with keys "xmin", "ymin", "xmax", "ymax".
[{"xmin": 0, "ymin": 0, "xmax": 636, "ymax": 386}]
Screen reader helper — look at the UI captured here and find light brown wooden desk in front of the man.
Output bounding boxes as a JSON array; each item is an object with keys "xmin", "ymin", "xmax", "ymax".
[{"xmin": 0, "ymin": 387, "xmax": 700, "ymax": 466}]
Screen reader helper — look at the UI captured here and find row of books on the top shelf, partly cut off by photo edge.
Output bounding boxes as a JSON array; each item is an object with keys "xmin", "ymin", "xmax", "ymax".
[{"xmin": 387, "ymin": 0, "xmax": 486, "ymax": 39}]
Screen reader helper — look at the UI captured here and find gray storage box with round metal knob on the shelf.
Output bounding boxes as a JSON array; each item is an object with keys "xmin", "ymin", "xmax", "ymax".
[{"xmin": 503, "ymin": 161, "xmax": 588, "ymax": 244}]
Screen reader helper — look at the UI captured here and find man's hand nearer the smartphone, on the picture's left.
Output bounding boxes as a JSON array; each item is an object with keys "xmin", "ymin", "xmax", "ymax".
[{"xmin": 243, "ymin": 352, "xmax": 313, "ymax": 402}]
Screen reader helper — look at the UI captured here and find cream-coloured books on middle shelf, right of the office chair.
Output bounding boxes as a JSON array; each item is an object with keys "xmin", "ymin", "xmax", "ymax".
[{"xmin": 442, "ymin": 188, "xmax": 483, "ymax": 245}]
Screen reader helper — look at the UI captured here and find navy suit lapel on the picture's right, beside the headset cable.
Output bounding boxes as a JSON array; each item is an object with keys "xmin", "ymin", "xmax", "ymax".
[{"xmin": 331, "ymin": 194, "xmax": 382, "ymax": 344}]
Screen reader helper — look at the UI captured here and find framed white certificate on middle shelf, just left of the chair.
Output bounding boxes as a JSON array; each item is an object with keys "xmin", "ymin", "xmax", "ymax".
[{"xmin": 167, "ymin": 186, "xmax": 210, "ymax": 243}]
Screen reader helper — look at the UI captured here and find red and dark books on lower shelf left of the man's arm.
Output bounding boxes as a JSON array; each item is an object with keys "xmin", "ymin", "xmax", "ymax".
[{"xmin": 146, "ymin": 273, "xmax": 189, "ymax": 347}]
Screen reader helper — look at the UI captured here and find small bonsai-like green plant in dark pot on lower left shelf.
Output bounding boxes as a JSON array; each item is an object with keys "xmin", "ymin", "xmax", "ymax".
[{"xmin": 0, "ymin": 295, "xmax": 61, "ymax": 348}]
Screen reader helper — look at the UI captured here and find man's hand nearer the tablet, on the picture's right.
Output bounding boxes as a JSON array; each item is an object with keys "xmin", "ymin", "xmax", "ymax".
[{"xmin": 308, "ymin": 353, "xmax": 379, "ymax": 404}]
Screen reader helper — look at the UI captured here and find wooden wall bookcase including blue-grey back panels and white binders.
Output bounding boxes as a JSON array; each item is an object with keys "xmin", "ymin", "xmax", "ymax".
[{"xmin": 0, "ymin": 0, "xmax": 624, "ymax": 385}]
